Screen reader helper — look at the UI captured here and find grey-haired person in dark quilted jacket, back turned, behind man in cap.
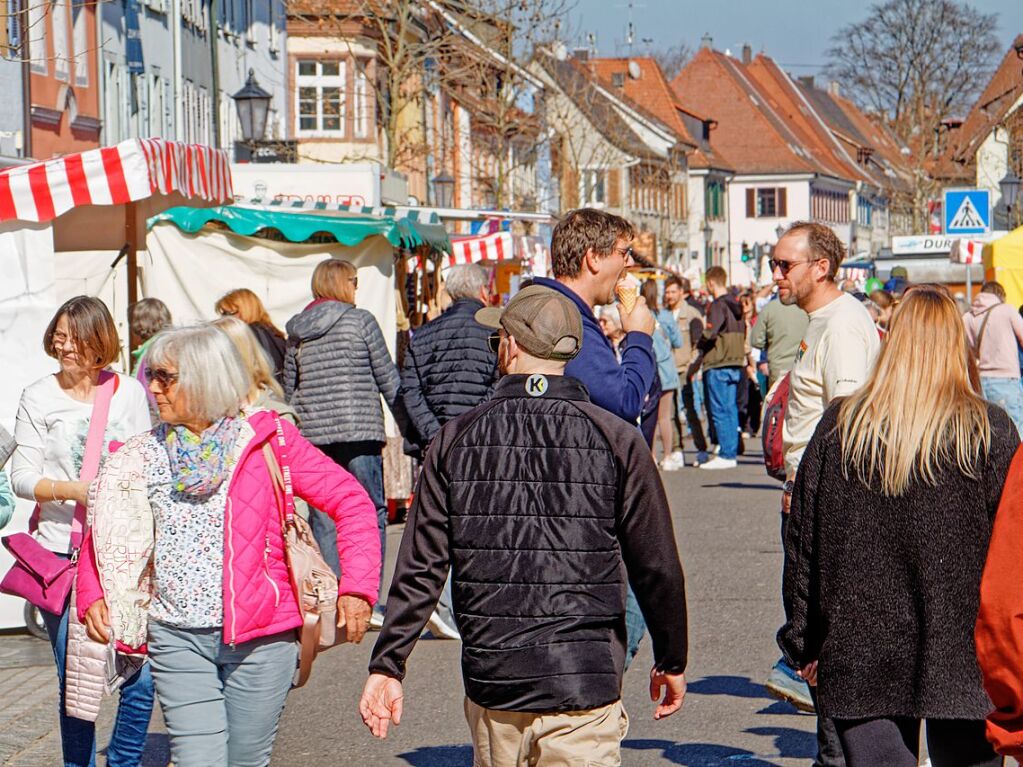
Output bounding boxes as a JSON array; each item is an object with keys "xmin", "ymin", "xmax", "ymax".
[{"xmin": 400, "ymin": 264, "xmax": 497, "ymax": 455}]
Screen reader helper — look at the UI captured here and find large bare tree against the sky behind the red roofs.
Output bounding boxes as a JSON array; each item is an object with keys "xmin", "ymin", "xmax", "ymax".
[{"xmin": 826, "ymin": 0, "xmax": 998, "ymax": 230}]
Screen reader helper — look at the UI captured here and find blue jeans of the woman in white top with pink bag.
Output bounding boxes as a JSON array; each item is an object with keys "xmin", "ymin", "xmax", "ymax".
[{"xmin": 40, "ymin": 606, "xmax": 152, "ymax": 767}]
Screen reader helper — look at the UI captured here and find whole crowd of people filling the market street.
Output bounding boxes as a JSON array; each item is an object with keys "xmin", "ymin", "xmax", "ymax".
[{"xmin": 0, "ymin": 209, "xmax": 1023, "ymax": 767}]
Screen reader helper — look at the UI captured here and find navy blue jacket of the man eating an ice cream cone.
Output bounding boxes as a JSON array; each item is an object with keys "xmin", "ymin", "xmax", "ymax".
[{"xmin": 533, "ymin": 277, "xmax": 657, "ymax": 423}]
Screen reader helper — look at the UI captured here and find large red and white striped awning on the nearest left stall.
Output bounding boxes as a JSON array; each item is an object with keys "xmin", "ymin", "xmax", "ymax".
[{"xmin": 0, "ymin": 138, "xmax": 234, "ymax": 222}]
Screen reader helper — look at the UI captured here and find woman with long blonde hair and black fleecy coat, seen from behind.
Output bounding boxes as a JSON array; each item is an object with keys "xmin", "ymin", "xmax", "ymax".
[{"xmin": 779, "ymin": 285, "xmax": 1019, "ymax": 767}]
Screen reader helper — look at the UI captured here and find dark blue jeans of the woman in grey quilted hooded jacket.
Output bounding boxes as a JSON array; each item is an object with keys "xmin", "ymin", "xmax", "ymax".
[{"xmin": 309, "ymin": 442, "xmax": 387, "ymax": 602}]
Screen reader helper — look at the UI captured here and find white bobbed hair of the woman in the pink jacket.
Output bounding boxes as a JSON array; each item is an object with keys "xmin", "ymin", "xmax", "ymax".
[{"xmin": 145, "ymin": 325, "xmax": 252, "ymax": 422}]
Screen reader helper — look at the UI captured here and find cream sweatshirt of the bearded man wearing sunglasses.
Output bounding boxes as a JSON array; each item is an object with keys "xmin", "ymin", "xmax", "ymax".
[{"xmin": 782, "ymin": 292, "xmax": 881, "ymax": 480}]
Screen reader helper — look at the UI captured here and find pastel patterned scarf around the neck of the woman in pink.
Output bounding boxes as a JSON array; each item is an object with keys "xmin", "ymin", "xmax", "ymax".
[{"xmin": 162, "ymin": 418, "xmax": 243, "ymax": 498}]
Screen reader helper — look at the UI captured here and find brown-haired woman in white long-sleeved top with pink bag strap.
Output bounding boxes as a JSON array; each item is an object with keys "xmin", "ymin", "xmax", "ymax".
[{"xmin": 11, "ymin": 296, "xmax": 153, "ymax": 767}]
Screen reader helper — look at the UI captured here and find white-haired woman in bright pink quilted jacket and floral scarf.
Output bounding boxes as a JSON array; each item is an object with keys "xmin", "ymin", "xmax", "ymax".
[{"xmin": 78, "ymin": 326, "xmax": 381, "ymax": 767}]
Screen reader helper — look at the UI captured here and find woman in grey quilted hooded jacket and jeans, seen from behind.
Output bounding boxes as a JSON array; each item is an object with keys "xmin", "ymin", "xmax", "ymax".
[{"xmin": 284, "ymin": 259, "xmax": 400, "ymax": 628}]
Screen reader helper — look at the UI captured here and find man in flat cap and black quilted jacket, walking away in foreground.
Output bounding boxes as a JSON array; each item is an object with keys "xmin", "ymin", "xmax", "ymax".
[{"xmin": 359, "ymin": 285, "xmax": 687, "ymax": 767}]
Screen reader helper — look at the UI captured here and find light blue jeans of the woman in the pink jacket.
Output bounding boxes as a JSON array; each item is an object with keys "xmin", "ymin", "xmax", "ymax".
[{"xmin": 149, "ymin": 621, "xmax": 298, "ymax": 767}]
